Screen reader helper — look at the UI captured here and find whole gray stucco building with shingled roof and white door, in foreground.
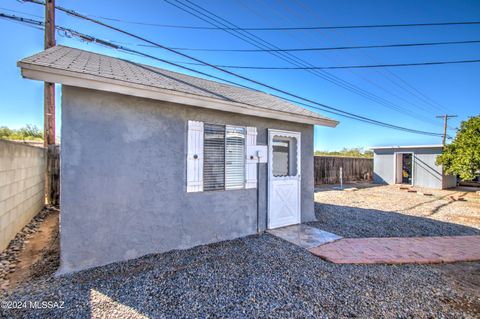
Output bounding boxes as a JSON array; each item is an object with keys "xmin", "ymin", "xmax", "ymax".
[{"xmin": 18, "ymin": 46, "xmax": 338, "ymax": 273}]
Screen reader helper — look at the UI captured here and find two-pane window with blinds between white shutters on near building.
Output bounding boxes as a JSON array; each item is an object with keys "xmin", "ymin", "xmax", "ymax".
[{"xmin": 203, "ymin": 123, "xmax": 246, "ymax": 191}]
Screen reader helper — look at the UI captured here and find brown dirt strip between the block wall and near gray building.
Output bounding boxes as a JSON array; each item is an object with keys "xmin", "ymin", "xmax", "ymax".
[{"xmin": 0, "ymin": 208, "xmax": 60, "ymax": 290}]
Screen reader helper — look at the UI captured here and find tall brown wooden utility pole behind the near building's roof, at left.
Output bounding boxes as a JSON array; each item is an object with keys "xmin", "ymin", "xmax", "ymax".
[{"xmin": 44, "ymin": 0, "xmax": 55, "ymax": 147}]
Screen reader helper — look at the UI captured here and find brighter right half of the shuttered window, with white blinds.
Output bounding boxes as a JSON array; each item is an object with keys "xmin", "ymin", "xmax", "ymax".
[{"xmin": 225, "ymin": 126, "xmax": 245, "ymax": 189}]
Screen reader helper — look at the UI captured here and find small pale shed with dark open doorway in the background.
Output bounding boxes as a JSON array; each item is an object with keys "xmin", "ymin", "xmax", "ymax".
[{"xmin": 372, "ymin": 145, "xmax": 457, "ymax": 189}]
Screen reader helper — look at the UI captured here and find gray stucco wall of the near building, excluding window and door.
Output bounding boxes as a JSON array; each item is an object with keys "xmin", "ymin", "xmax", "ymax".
[{"xmin": 59, "ymin": 86, "xmax": 315, "ymax": 273}]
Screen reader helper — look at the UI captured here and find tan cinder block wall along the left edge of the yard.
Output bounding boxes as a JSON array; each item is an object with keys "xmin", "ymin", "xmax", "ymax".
[{"xmin": 0, "ymin": 140, "xmax": 47, "ymax": 252}]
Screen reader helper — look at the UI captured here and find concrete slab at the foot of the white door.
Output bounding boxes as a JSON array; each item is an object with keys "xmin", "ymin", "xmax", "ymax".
[{"xmin": 267, "ymin": 224, "xmax": 342, "ymax": 249}]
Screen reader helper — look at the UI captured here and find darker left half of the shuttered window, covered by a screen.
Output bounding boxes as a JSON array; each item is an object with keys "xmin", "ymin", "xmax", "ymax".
[{"xmin": 203, "ymin": 124, "xmax": 225, "ymax": 191}]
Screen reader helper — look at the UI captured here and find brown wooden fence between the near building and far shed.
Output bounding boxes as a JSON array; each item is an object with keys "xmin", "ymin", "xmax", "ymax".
[{"xmin": 314, "ymin": 156, "xmax": 373, "ymax": 185}]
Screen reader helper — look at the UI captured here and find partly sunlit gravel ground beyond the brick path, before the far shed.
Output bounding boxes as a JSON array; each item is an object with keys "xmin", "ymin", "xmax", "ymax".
[{"xmin": 310, "ymin": 185, "xmax": 480, "ymax": 237}]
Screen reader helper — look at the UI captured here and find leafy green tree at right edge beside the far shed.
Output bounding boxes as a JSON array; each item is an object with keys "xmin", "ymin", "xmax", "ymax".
[{"xmin": 437, "ymin": 116, "xmax": 480, "ymax": 181}]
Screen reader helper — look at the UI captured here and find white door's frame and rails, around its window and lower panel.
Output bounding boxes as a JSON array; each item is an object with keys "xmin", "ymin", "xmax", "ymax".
[{"xmin": 266, "ymin": 129, "xmax": 302, "ymax": 229}]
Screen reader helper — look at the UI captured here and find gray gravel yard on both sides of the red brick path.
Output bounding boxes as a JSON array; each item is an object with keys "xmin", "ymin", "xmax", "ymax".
[{"xmin": 0, "ymin": 187, "xmax": 480, "ymax": 318}]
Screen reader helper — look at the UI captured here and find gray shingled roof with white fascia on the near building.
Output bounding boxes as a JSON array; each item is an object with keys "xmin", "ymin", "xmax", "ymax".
[{"xmin": 18, "ymin": 46, "xmax": 338, "ymax": 127}]
